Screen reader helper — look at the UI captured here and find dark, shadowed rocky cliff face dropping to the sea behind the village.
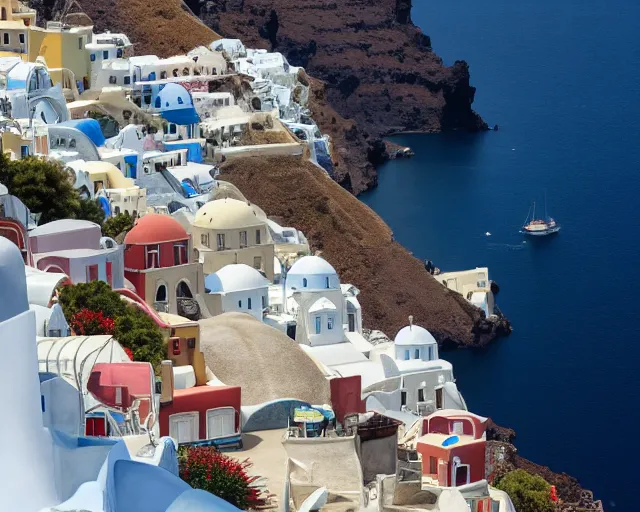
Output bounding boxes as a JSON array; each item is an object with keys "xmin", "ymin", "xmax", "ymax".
[{"xmin": 187, "ymin": 0, "xmax": 486, "ymax": 194}]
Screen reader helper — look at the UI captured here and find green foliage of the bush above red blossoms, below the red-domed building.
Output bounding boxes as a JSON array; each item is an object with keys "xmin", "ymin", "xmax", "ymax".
[{"xmin": 59, "ymin": 281, "xmax": 167, "ymax": 372}]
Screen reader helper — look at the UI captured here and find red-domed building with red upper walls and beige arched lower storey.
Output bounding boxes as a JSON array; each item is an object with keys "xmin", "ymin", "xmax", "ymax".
[{"xmin": 124, "ymin": 214, "xmax": 204, "ymax": 314}]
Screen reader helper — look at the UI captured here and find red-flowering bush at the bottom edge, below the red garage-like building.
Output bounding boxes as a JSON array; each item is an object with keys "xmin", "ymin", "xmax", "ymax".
[{"xmin": 178, "ymin": 446, "xmax": 265, "ymax": 510}]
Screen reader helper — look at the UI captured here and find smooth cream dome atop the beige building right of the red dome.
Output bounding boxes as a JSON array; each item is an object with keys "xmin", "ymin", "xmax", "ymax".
[{"xmin": 193, "ymin": 198, "xmax": 265, "ymax": 231}]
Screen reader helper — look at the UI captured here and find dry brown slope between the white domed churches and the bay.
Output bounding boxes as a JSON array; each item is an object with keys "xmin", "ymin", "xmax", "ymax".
[{"xmin": 221, "ymin": 157, "xmax": 504, "ymax": 345}]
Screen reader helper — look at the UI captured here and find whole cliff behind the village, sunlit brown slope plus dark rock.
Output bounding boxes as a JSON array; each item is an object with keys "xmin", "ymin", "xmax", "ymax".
[{"xmin": 48, "ymin": 0, "xmax": 486, "ymax": 194}]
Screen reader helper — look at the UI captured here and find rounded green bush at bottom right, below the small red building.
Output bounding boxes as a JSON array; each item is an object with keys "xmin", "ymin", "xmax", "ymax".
[{"xmin": 495, "ymin": 469, "xmax": 555, "ymax": 512}]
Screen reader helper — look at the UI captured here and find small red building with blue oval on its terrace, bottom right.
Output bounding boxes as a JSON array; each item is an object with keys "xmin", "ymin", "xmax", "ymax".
[{"xmin": 417, "ymin": 409, "xmax": 488, "ymax": 487}]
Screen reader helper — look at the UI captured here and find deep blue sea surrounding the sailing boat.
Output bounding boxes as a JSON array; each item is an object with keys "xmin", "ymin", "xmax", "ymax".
[{"xmin": 362, "ymin": 0, "xmax": 640, "ymax": 512}]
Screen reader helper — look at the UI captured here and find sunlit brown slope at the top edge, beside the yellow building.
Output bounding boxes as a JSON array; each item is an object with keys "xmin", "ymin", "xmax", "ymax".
[{"xmin": 79, "ymin": 0, "xmax": 220, "ymax": 57}]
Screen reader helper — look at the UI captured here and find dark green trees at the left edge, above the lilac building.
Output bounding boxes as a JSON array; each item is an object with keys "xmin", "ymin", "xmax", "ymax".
[{"xmin": 0, "ymin": 154, "xmax": 104, "ymax": 224}]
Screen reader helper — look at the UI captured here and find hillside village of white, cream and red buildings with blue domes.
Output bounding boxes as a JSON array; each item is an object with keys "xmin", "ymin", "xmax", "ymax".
[{"xmin": 0, "ymin": 4, "xmax": 601, "ymax": 512}]
